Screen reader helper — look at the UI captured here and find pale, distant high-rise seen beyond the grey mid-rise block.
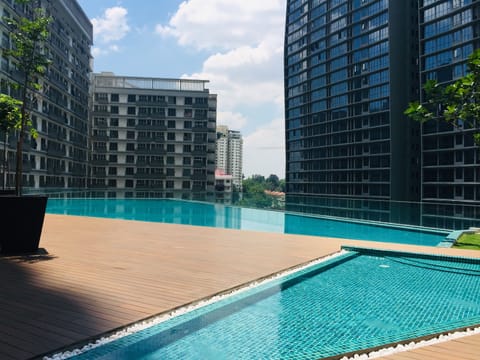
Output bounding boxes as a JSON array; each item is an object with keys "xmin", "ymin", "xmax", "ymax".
[{"xmin": 216, "ymin": 125, "xmax": 243, "ymax": 191}]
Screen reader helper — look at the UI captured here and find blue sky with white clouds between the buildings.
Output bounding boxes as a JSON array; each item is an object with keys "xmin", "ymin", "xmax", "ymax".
[{"xmin": 77, "ymin": 0, "xmax": 286, "ymax": 179}]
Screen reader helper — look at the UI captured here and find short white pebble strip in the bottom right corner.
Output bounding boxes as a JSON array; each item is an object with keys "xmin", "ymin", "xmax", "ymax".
[{"xmin": 341, "ymin": 327, "xmax": 480, "ymax": 360}]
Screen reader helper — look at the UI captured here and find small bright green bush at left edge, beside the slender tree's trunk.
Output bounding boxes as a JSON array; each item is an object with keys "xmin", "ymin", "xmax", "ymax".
[{"xmin": 0, "ymin": 94, "xmax": 22, "ymax": 189}]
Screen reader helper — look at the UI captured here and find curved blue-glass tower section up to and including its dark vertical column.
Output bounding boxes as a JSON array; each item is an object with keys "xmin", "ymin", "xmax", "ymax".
[{"xmin": 284, "ymin": 0, "xmax": 420, "ymax": 220}]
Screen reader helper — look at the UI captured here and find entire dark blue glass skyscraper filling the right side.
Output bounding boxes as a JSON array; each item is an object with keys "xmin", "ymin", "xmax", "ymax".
[{"xmin": 284, "ymin": 0, "xmax": 480, "ymax": 225}]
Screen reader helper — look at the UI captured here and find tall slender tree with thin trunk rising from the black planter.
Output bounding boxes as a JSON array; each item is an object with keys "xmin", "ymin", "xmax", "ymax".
[{"xmin": 3, "ymin": 0, "xmax": 51, "ymax": 195}]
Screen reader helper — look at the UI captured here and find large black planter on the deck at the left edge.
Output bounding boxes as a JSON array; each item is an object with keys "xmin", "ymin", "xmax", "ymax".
[{"xmin": 0, "ymin": 195, "xmax": 47, "ymax": 254}]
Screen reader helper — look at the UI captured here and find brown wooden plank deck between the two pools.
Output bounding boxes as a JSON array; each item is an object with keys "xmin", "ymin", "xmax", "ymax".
[{"xmin": 0, "ymin": 215, "xmax": 480, "ymax": 360}]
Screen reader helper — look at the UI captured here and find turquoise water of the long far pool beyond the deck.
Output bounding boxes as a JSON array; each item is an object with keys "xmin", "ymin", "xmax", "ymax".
[{"xmin": 47, "ymin": 199, "xmax": 446, "ymax": 246}]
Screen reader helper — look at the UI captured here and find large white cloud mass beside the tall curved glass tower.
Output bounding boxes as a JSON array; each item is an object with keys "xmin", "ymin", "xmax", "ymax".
[{"xmin": 156, "ymin": 0, "xmax": 286, "ymax": 178}]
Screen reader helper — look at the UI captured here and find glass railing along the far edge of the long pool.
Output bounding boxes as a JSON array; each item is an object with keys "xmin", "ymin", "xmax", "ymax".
[{"xmin": 25, "ymin": 188, "xmax": 480, "ymax": 230}]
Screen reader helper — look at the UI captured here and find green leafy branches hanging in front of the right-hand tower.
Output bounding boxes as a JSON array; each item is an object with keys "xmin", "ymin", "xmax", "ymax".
[{"xmin": 405, "ymin": 49, "xmax": 480, "ymax": 145}]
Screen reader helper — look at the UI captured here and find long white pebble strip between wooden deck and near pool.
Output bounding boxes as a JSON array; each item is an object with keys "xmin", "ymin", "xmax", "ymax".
[{"xmin": 43, "ymin": 250, "xmax": 348, "ymax": 360}]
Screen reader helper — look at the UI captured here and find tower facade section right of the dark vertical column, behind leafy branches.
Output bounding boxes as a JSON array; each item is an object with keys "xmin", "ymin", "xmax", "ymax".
[{"xmin": 419, "ymin": 0, "xmax": 480, "ymax": 228}]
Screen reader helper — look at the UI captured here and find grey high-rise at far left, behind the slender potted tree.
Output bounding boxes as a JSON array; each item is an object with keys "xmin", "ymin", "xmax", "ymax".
[{"xmin": 0, "ymin": 0, "xmax": 93, "ymax": 188}]
